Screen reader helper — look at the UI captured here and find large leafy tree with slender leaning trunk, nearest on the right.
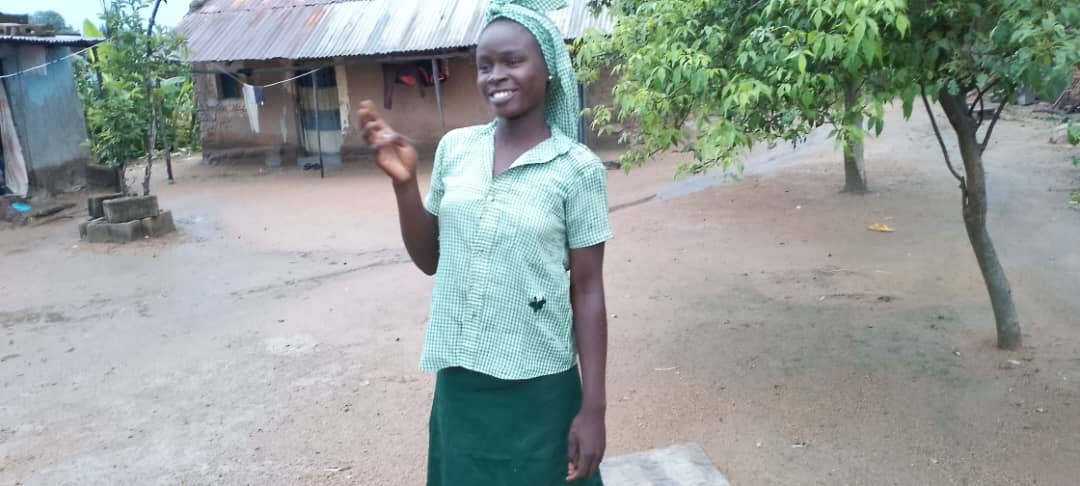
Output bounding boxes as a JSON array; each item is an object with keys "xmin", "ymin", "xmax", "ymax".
[{"xmin": 578, "ymin": 0, "xmax": 1080, "ymax": 349}]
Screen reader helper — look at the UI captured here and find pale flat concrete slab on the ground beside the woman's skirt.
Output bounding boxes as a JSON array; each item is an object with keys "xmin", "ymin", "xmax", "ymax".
[{"xmin": 600, "ymin": 444, "xmax": 731, "ymax": 486}]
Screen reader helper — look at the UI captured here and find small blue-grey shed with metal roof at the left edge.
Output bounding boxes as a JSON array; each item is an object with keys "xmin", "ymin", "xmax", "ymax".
[{"xmin": 0, "ymin": 14, "xmax": 102, "ymax": 195}]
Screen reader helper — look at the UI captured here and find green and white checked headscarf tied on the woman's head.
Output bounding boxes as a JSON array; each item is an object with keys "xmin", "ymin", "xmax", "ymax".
[{"xmin": 484, "ymin": 0, "xmax": 581, "ymax": 140}]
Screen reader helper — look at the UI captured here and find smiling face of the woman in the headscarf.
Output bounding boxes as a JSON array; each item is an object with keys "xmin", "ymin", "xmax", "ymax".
[{"xmin": 476, "ymin": 19, "xmax": 548, "ymax": 120}]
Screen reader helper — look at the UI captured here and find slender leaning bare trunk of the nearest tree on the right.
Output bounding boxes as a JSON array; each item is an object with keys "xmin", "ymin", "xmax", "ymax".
[{"xmin": 939, "ymin": 90, "xmax": 1023, "ymax": 350}]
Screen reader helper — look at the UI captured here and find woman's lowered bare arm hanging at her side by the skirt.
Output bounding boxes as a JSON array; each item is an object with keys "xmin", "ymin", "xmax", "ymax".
[{"xmin": 567, "ymin": 243, "xmax": 607, "ymax": 482}]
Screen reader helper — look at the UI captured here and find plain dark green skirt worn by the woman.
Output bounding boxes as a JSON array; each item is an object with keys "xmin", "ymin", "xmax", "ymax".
[{"xmin": 428, "ymin": 367, "xmax": 603, "ymax": 486}]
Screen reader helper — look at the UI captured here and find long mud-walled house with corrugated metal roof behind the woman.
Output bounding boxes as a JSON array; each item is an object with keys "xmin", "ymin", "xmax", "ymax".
[{"xmin": 175, "ymin": 0, "xmax": 611, "ymax": 165}]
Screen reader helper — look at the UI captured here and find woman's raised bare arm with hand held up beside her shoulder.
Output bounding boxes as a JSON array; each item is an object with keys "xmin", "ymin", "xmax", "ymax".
[{"xmin": 360, "ymin": 100, "xmax": 438, "ymax": 275}]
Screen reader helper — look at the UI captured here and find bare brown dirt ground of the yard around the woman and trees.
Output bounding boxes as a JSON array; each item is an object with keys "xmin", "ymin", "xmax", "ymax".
[{"xmin": 6, "ymin": 110, "xmax": 1080, "ymax": 486}]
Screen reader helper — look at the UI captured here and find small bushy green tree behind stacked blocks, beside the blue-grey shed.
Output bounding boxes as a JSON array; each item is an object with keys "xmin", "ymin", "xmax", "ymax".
[{"xmin": 77, "ymin": 0, "xmax": 194, "ymax": 194}]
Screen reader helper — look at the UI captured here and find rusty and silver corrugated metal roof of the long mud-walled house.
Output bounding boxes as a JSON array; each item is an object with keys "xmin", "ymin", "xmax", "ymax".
[{"xmin": 176, "ymin": 0, "xmax": 612, "ymax": 62}]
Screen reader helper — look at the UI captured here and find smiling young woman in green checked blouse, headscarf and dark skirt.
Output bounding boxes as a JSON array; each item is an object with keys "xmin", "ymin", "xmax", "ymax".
[{"xmin": 360, "ymin": 0, "xmax": 611, "ymax": 486}]
